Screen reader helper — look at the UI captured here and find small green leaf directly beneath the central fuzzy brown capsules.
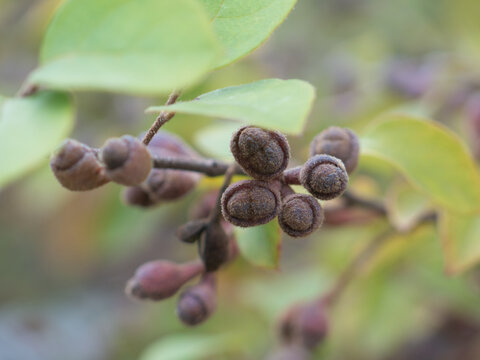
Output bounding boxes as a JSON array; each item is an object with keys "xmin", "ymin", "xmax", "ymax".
[{"xmin": 235, "ymin": 221, "xmax": 281, "ymax": 269}]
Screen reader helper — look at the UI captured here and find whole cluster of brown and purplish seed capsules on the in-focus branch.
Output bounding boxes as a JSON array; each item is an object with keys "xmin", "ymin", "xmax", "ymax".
[{"xmin": 50, "ymin": 126, "xmax": 359, "ymax": 325}]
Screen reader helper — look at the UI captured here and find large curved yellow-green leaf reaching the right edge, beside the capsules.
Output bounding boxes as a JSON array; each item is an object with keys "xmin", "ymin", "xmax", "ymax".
[{"xmin": 361, "ymin": 114, "xmax": 480, "ymax": 213}]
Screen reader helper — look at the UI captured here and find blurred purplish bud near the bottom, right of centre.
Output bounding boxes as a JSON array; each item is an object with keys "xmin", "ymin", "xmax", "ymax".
[{"xmin": 279, "ymin": 301, "xmax": 328, "ymax": 349}]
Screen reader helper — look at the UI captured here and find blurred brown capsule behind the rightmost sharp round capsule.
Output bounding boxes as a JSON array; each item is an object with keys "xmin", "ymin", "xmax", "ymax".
[{"xmin": 310, "ymin": 126, "xmax": 360, "ymax": 174}]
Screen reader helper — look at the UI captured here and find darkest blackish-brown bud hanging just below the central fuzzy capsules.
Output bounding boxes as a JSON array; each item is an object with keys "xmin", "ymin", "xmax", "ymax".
[{"xmin": 198, "ymin": 222, "xmax": 230, "ymax": 271}]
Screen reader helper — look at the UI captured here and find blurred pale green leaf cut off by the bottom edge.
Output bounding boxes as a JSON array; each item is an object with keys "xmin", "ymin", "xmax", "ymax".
[{"xmin": 140, "ymin": 334, "xmax": 232, "ymax": 360}]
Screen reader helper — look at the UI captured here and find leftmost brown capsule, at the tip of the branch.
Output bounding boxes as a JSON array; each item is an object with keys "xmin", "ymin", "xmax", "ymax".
[{"xmin": 50, "ymin": 139, "xmax": 109, "ymax": 191}]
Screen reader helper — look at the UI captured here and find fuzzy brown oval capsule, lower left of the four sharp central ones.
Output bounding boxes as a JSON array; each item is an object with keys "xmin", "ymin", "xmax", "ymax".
[{"xmin": 222, "ymin": 180, "xmax": 281, "ymax": 227}]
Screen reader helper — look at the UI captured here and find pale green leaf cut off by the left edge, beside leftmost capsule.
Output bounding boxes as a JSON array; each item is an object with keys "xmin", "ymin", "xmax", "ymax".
[{"xmin": 0, "ymin": 91, "xmax": 74, "ymax": 187}]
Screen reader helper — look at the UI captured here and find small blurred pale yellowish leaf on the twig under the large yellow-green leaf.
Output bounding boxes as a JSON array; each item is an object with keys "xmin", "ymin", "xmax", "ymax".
[{"xmin": 386, "ymin": 182, "xmax": 431, "ymax": 232}]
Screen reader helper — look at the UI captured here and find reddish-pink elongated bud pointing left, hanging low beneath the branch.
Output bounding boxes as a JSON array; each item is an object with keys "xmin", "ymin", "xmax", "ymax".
[{"xmin": 125, "ymin": 260, "xmax": 205, "ymax": 300}]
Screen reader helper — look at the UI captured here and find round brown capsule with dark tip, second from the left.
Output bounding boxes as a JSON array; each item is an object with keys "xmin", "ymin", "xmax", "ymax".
[{"xmin": 101, "ymin": 135, "xmax": 152, "ymax": 186}]
